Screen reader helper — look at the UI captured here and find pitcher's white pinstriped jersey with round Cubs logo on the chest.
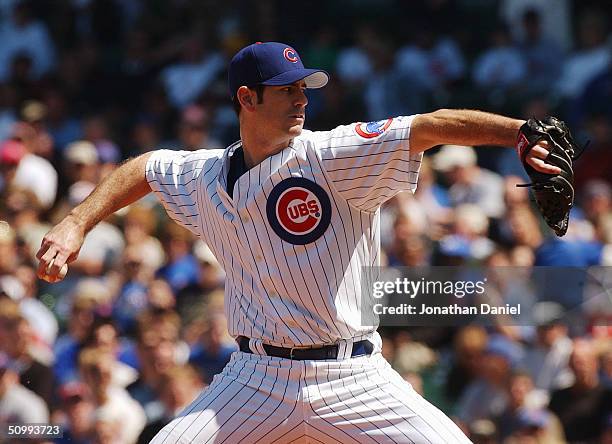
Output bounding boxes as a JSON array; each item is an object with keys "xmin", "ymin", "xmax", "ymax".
[{"xmin": 146, "ymin": 116, "xmax": 422, "ymax": 347}]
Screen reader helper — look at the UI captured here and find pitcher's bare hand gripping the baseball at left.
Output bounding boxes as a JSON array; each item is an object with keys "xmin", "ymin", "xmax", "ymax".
[{"xmin": 36, "ymin": 215, "xmax": 85, "ymax": 283}]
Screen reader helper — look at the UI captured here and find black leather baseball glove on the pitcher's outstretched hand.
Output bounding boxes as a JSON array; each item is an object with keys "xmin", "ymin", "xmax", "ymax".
[{"xmin": 516, "ymin": 116, "xmax": 580, "ymax": 236}]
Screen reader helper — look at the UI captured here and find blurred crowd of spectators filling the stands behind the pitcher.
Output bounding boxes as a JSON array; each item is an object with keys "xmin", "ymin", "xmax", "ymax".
[{"xmin": 0, "ymin": 0, "xmax": 612, "ymax": 443}]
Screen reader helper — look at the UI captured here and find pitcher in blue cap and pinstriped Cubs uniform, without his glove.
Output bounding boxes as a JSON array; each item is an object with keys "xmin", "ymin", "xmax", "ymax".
[{"xmin": 37, "ymin": 42, "xmax": 558, "ymax": 444}]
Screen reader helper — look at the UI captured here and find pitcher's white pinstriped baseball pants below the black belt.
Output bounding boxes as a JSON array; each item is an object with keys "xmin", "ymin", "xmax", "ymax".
[{"xmin": 151, "ymin": 352, "xmax": 470, "ymax": 444}]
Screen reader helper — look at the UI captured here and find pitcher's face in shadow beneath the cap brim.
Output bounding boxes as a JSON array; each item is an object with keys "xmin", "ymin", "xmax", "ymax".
[{"xmin": 258, "ymin": 80, "xmax": 308, "ymax": 139}]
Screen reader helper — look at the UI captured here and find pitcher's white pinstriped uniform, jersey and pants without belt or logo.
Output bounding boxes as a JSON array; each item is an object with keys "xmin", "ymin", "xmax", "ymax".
[{"xmin": 146, "ymin": 117, "xmax": 468, "ymax": 444}]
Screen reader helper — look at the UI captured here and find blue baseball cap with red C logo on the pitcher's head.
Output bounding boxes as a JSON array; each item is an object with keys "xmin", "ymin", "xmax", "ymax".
[{"xmin": 228, "ymin": 42, "xmax": 329, "ymax": 97}]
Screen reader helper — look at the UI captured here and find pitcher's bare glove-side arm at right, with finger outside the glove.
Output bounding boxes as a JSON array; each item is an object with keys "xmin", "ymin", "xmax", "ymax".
[{"xmin": 410, "ymin": 109, "xmax": 560, "ymax": 174}]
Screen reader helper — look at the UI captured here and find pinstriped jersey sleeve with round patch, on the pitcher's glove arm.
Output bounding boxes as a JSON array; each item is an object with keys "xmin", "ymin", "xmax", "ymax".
[{"xmin": 317, "ymin": 116, "xmax": 423, "ymax": 211}]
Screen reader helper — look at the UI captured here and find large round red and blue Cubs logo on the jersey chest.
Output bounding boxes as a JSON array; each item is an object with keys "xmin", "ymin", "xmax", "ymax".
[{"xmin": 266, "ymin": 177, "xmax": 331, "ymax": 245}]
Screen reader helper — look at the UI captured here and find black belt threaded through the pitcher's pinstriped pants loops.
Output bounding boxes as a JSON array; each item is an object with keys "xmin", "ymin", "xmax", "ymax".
[{"xmin": 236, "ymin": 336, "xmax": 374, "ymax": 361}]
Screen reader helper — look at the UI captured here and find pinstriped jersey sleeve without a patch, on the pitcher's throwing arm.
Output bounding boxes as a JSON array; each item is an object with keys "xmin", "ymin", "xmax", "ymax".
[{"xmin": 146, "ymin": 150, "xmax": 218, "ymax": 234}]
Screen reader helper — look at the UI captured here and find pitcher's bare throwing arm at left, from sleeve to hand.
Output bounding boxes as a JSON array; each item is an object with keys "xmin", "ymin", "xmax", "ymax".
[{"xmin": 36, "ymin": 153, "xmax": 151, "ymax": 282}]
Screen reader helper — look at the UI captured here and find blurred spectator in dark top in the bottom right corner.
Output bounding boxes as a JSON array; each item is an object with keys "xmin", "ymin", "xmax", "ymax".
[{"xmin": 549, "ymin": 339, "xmax": 612, "ymax": 442}]
